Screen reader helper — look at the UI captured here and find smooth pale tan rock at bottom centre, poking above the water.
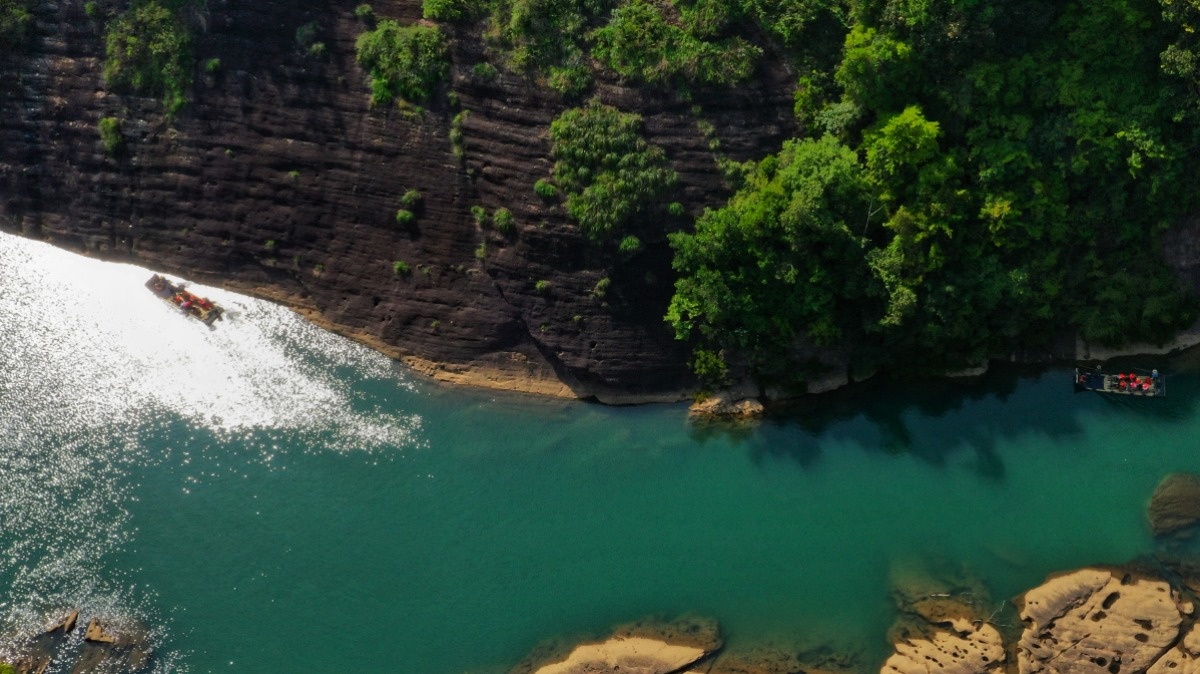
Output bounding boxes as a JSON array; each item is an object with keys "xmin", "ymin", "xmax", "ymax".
[{"xmin": 535, "ymin": 637, "xmax": 708, "ymax": 674}]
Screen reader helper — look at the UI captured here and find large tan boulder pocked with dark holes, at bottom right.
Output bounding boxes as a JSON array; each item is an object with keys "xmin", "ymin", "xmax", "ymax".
[{"xmin": 1016, "ymin": 568, "xmax": 1182, "ymax": 674}]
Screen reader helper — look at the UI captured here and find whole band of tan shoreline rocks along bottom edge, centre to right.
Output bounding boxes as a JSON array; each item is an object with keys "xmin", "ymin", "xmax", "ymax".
[{"xmin": 510, "ymin": 567, "xmax": 1200, "ymax": 674}]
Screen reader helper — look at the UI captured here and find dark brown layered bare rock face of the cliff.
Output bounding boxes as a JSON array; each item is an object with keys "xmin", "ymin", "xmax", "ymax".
[{"xmin": 0, "ymin": 0, "xmax": 794, "ymax": 401}]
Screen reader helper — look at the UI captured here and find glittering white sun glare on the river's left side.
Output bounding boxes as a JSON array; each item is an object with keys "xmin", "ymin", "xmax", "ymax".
[{"xmin": 0, "ymin": 235, "xmax": 421, "ymax": 672}]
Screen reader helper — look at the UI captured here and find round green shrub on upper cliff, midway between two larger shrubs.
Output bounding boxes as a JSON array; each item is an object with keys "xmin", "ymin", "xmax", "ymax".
[{"xmin": 356, "ymin": 20, "xmax": 450, "ymax": 106}]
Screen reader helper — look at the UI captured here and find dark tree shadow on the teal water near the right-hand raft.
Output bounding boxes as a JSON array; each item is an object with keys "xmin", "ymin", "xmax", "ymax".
[{"xmin": 692, "ymin": 354, "xmax": 1200, "ymax": 481}]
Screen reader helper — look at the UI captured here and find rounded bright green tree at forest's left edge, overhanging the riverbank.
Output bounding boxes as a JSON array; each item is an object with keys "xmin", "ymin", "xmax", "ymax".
[{"xmin": 666, "ymin": 136, "xmax": 880, "ymax": 362}]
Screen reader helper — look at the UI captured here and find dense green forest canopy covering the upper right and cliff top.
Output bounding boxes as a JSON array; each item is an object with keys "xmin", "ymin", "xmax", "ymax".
[{"xmin": 417, "ymin": 0, "xmax": 1200, "ymax": 381}]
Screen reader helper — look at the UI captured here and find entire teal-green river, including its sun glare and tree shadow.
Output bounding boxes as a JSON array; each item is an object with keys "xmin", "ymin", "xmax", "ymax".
[{"xmin": 0, "ymin": 235, "xmax": 1200, "ymax": 674}]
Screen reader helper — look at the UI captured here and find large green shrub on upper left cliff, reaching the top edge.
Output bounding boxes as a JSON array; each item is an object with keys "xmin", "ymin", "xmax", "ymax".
[{"xmin": 104, "ymin": 0, "xmax": 194, "ymax": 114}]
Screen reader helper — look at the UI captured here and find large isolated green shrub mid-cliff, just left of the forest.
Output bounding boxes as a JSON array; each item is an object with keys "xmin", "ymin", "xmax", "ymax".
[{"xmin": 550, "ymin": 101, "xmax": 677, "ymax": 241}]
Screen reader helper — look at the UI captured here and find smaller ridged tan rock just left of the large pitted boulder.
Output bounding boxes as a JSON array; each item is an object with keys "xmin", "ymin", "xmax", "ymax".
[{"xmin": 880, "ymin": 619, "xmax": 1004, "ymax": 674}]
